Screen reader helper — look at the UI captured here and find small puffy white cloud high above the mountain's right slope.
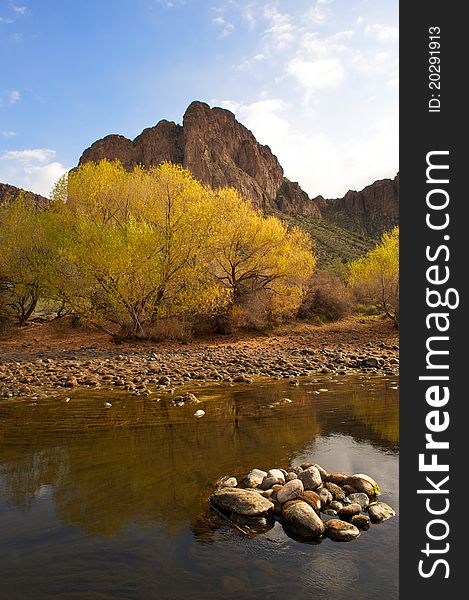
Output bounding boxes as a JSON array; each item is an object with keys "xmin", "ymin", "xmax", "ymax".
[{"xmin": 288, "ymin": 57, "xmax": 344, "ymax": 92}]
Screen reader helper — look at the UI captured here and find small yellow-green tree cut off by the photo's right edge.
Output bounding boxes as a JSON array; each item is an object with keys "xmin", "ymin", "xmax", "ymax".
[{"xmin": 349, "ymin": 227, "xmax": 399, "ymax": 326}]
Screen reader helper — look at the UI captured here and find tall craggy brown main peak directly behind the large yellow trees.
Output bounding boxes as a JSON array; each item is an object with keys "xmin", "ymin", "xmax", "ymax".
[{"xmin": 79, "ymin": 102, "xmax": 283, "ymax": 209}]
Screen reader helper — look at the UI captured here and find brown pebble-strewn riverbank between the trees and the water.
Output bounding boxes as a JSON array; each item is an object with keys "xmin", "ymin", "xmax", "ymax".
[{"xmin": 0, "ymin": 318, "xmax": 399, "ymax": 398}]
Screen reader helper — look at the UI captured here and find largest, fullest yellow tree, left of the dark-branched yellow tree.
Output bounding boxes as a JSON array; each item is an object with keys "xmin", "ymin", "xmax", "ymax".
[{"xmin": 52, "ymin": 161, "xmax": 224, "ymax": 337}]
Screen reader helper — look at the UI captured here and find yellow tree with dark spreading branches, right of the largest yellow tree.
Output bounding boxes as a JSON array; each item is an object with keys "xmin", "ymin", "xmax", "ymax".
[{"xmin": 208, "ymin": 188, "xmax": 316, "ymax": 326}]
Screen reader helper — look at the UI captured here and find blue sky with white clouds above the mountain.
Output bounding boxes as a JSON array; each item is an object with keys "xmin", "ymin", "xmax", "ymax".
[{"xmin": 0, "ymin": 0, "xmax": 398, "ymax": 198}]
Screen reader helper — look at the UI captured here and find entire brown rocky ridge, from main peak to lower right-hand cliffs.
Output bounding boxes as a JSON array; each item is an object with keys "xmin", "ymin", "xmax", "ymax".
[{"xmin": 79, "ymin": 102, "xmax": 399, "ymax": 237}]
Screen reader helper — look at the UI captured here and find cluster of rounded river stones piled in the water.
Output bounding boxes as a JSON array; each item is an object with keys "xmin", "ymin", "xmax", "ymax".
[{"xmin": 210, "ymin": 464, "xmax": 396, "ymax": 541}]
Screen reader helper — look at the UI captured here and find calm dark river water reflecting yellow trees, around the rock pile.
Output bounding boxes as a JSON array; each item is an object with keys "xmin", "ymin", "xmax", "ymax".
[{"xmin": 0, "ymin": 377, "xmax": 399, "ymax": 600}]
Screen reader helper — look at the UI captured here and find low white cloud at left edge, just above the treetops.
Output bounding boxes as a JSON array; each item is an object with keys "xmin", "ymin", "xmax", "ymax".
[{"xmin": 0, "ymin": 148, "xmax": 68, "ymax": 196}]
